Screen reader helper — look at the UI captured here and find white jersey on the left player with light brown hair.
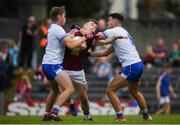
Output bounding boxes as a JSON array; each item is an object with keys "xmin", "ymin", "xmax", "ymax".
[{"xmin": 42, "ymin": 24, "xmax": 67, "ymax": 64}]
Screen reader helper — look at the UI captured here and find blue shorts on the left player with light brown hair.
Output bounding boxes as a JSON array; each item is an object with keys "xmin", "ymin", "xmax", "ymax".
[{"xmin": 42, "ymin": 64, "xmax": 64, "ymax": 80}]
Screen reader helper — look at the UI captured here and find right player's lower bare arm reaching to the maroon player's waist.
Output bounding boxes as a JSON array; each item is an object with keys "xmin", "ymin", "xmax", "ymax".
[{"xmin": 89, "ymin": 46, "xmax": 114, "ymax": 57}]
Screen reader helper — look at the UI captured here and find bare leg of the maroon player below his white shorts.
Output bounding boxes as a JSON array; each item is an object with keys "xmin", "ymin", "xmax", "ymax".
[{"xmin": 74, "ymin": 84, "xmax": 92, "ymax": 121}]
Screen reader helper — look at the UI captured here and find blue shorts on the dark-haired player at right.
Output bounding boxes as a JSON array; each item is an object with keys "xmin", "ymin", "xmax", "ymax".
[{"xmin": 119, "ymin": 62, "xmax": 144, "ymax": 83}]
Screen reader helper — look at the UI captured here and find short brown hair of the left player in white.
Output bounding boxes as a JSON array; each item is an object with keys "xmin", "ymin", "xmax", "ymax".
[{"xmin": 50, "ymin": 6, "xmax": 66, "ymax": 20}]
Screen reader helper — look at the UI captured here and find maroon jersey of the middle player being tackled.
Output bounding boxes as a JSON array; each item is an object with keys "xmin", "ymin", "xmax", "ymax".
[{"xmin": 63, "ymin": 31, "xmax": 94, "ymax": 71}]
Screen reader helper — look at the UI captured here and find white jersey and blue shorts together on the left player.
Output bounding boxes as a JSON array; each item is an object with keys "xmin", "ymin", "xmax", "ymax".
[{"xmin": 42, "ymin": 24, "xmax": 67, "ymax": 80}]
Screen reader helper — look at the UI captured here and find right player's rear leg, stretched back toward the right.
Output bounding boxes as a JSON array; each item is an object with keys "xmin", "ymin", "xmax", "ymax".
[{"xmin": 128, "ymin": 81, "xmax": 152, "ymax": 120}]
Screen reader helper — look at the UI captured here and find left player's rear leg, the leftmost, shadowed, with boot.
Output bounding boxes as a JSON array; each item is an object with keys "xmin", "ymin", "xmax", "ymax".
[{"xmin": 42, "ymin": 81, "xmax": 59, "ymax": 121}]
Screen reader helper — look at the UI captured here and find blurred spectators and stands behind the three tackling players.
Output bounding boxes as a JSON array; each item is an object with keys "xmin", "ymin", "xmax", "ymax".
[{"xmin": 0, "ymin": 0, "xmax": 180, "ymax": 112}]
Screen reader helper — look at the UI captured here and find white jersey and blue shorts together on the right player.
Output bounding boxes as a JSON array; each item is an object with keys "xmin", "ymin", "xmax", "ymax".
[{"xmin": 103, "ymin": 27, "xmax": 144, "ymax": 83}]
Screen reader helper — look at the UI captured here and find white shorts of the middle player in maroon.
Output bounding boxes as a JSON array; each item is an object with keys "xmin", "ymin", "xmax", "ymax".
[{"xmin": 65, "ymin": 70, "xmax": 87, "ymax": 85}]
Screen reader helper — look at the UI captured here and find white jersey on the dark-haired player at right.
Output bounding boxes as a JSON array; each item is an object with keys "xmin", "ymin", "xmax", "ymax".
[{"xmin": 103, "ymin": 27, "xmax": 141, "ymax": 67}]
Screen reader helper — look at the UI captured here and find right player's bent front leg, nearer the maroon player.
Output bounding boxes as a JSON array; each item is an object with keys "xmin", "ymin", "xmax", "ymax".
[{"xmin": 106, "ymin": 74, "xmax": 128, "ymax": 121}]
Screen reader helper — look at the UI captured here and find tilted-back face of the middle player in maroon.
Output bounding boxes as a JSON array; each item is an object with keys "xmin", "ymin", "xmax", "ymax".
[{"xmin": 83, "ymin": 21, "xmax": 97, "ymax": 32}]
